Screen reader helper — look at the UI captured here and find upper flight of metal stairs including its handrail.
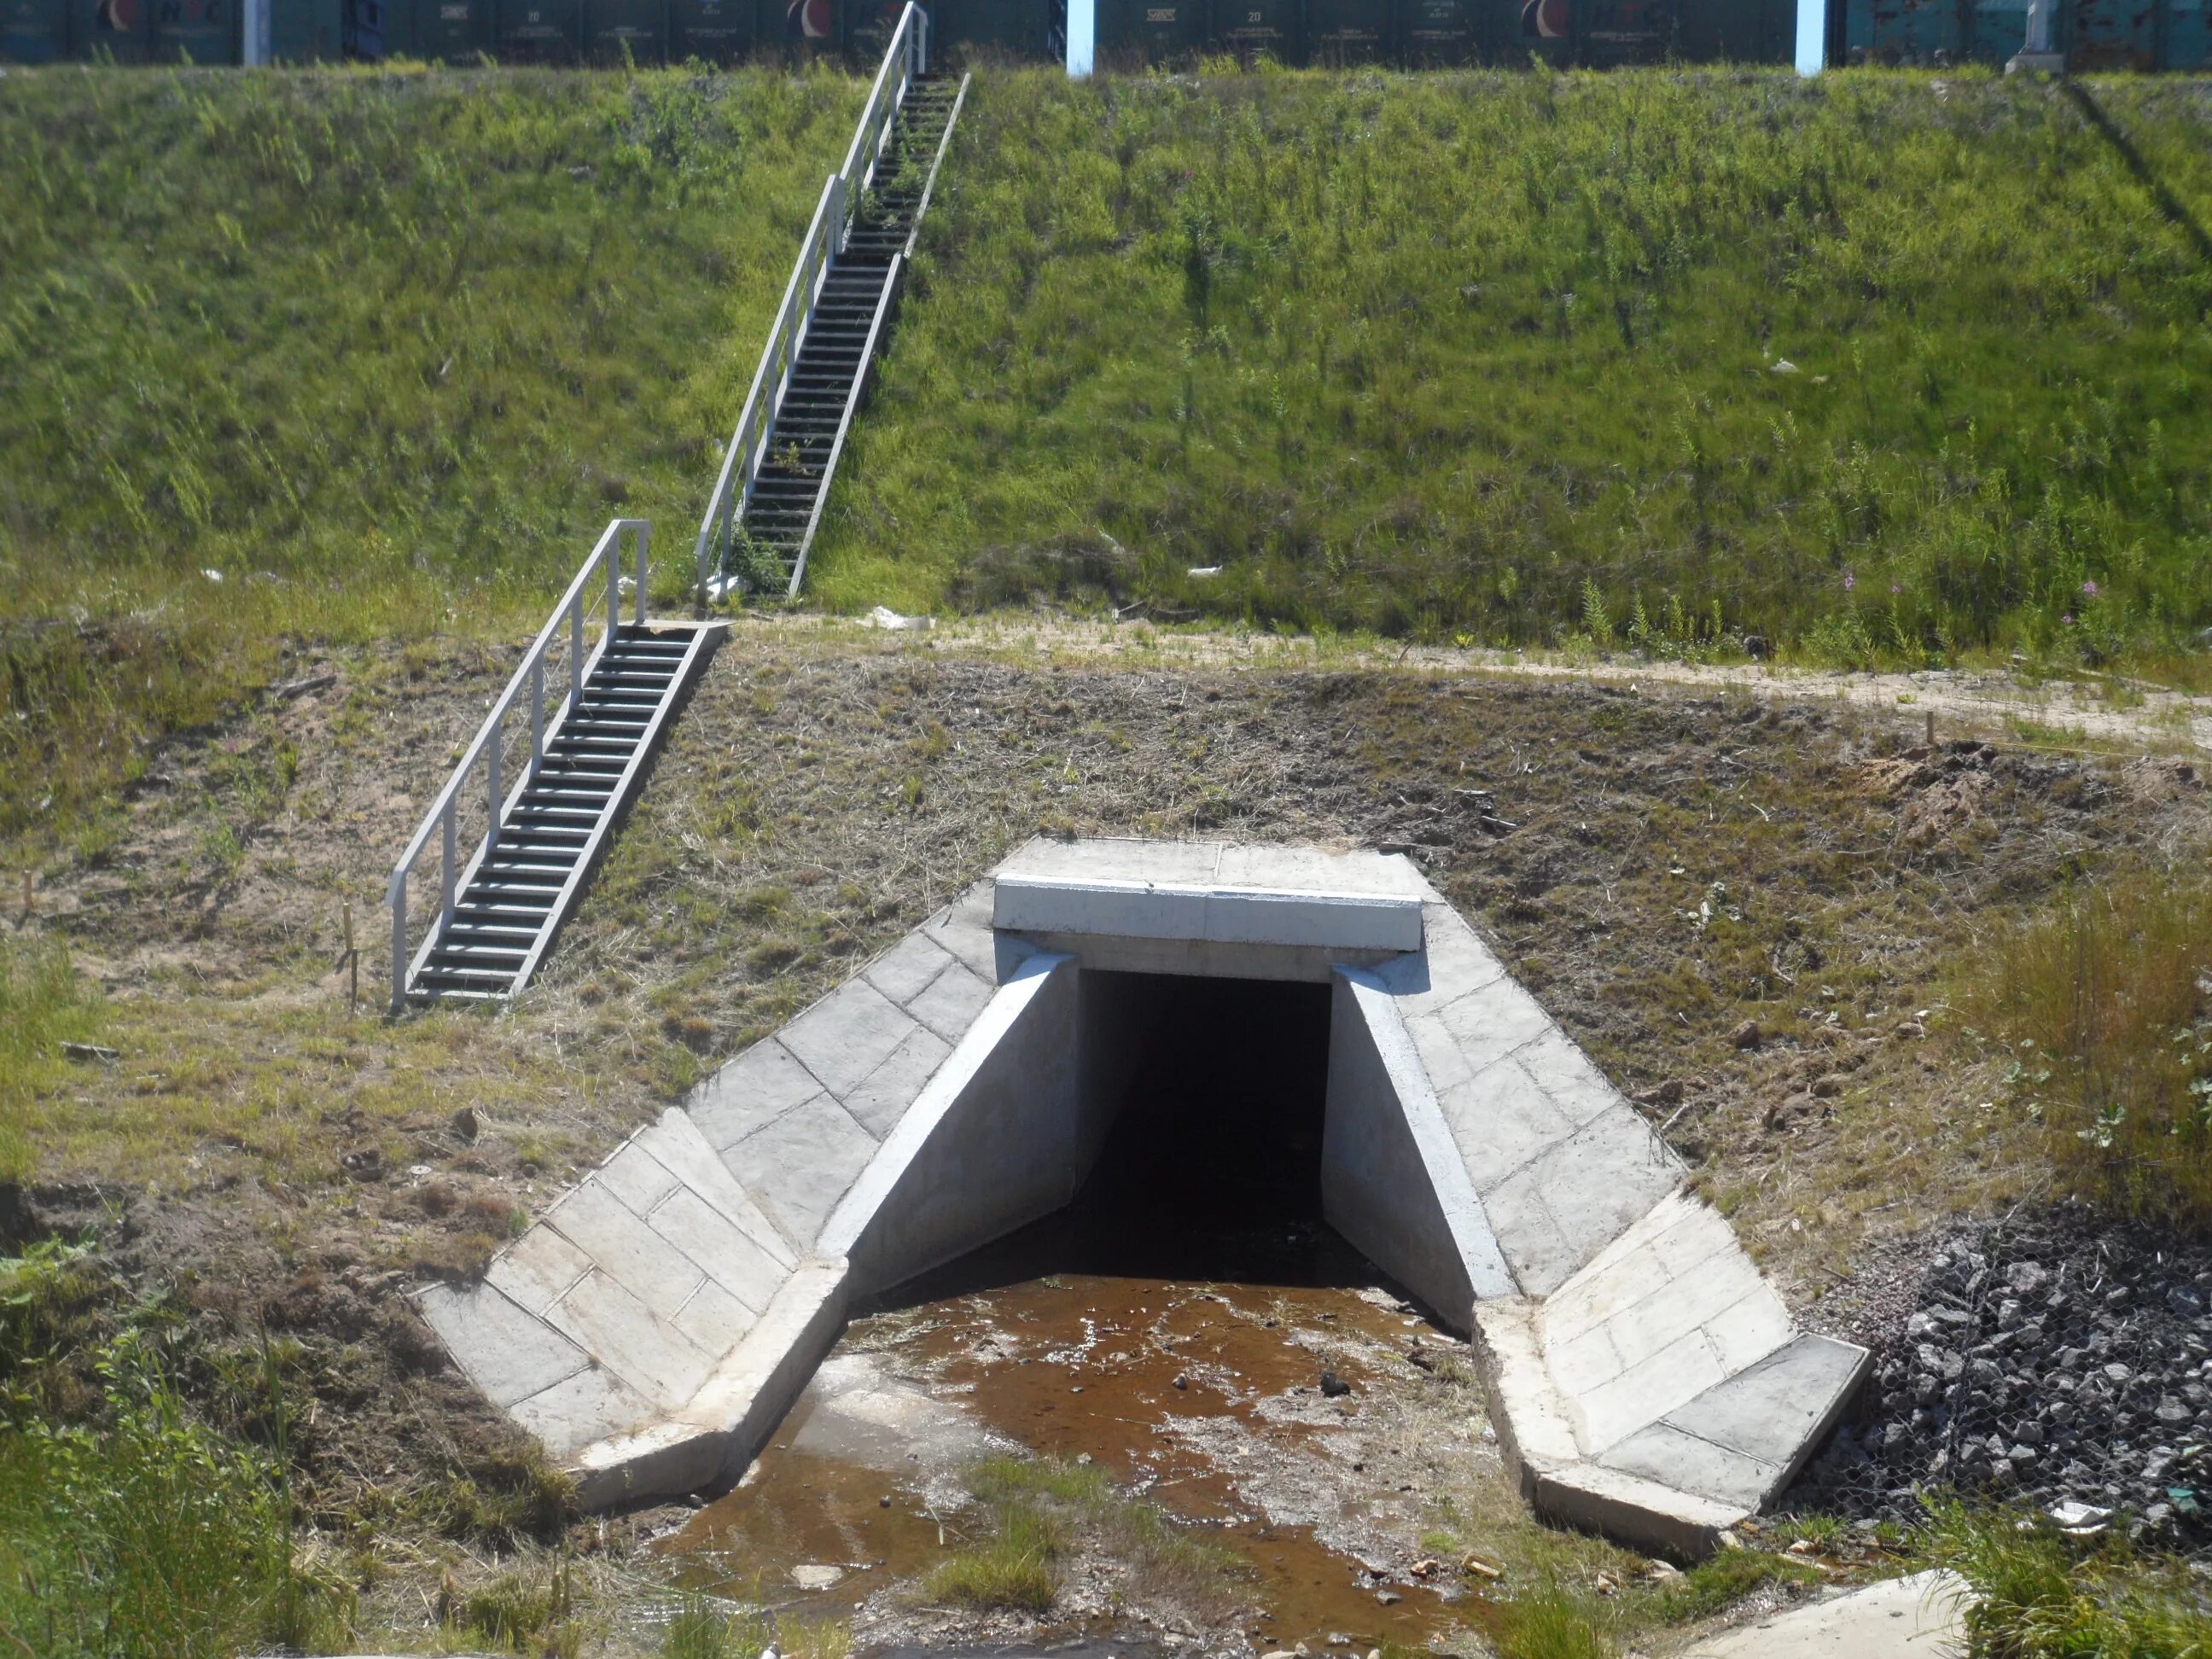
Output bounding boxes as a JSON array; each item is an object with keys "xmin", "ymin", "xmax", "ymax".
[{"xmin": 699, "ymin": 4, "xmax": 967, "ymax": 597}]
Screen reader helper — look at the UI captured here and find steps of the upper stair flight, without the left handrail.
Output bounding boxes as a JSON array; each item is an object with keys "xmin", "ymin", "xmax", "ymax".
[{"xmin": 739, "ymin": 75, "xmax": 967, "ymax": 593}]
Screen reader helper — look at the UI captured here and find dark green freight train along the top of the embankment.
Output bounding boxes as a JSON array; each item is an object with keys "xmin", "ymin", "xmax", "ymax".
[{"xmin": 0, "ymin": 0, "xmax": 2212, "ymax": 71}]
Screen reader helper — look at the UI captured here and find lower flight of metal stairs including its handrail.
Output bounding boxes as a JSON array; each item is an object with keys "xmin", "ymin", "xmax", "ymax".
[{"xmin": 387, "ymin": 518, "xmax": 724, "ymax": 1009}]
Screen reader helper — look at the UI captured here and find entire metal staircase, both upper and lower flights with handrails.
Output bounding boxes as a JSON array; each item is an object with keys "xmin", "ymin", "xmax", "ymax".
[{"xmin": 385, "ymin": 0, "xmax": 967, "ymax": 1011}]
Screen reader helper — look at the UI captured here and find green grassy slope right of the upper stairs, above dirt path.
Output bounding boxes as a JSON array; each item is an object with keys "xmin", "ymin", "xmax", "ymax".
[{"xmin": 812, "ymin": 71, "xmax": 2212, "ymax": 666}]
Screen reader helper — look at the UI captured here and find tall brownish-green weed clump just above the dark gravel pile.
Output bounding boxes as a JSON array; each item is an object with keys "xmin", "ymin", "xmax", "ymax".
[{"xmin": 1960, "ymin": 874, "xmax": 2212, "ymax": 1228}]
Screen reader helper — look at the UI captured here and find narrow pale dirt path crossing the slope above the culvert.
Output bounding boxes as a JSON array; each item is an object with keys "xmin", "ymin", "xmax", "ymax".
[{"xmin": 748, "ymin": 613, "xmax": 2212, "ymax": 750}]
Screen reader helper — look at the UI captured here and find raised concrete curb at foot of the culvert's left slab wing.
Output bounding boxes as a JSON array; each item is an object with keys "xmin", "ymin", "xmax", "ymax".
[{"xmin": 571, "ymin": 1256, "xmax": 847, "ymax": 1509}]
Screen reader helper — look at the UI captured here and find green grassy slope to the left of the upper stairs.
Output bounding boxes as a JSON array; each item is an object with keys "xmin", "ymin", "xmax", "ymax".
[{"xmin": 0, "ymin": 67, "xmax": 860, "ymax": 834}]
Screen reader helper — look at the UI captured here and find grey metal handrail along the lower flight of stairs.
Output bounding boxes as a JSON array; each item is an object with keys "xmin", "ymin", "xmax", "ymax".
[{"xmin": 385, "ymin": 518, "xmax": 653, "ymax": 1011}]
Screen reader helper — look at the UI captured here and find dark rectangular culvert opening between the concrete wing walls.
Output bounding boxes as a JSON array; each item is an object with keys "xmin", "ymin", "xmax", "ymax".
[{"xmin": 874, "ymin": 969, "xmax": 1376, "ymax": 1305}]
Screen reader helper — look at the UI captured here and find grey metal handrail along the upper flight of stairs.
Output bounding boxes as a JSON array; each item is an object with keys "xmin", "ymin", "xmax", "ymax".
[{"xmin": 699, "ymin": 0, "xmax": 929, "ymax": 604}]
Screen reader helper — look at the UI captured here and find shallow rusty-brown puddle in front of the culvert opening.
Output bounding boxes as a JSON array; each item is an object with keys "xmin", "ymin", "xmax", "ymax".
[{"xmin": 670, "ymin": 1277, "xmax": 1458, "ymax": 1652}]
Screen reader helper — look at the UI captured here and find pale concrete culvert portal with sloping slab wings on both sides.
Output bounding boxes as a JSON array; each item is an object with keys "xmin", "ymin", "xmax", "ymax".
[{"xmin": 420, "ymin": 841, "xmax": 1867, "ymax": 1557}]
